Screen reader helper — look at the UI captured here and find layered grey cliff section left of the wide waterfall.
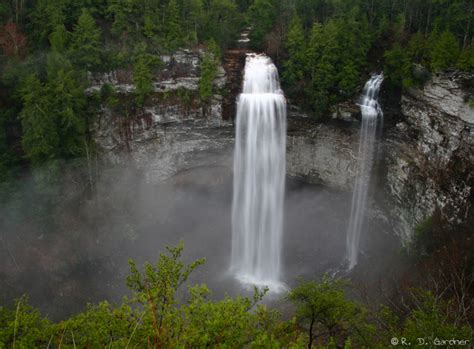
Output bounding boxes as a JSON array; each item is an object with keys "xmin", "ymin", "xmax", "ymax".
[{"xmin": 92, "ymin": 50, "xmax": 234, "ymax": 182}]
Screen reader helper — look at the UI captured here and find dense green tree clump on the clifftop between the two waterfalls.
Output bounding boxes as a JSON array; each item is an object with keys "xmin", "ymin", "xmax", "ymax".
[{"xmin": 283, "ymin": 15, "xmax": 371, "ymax": 117}]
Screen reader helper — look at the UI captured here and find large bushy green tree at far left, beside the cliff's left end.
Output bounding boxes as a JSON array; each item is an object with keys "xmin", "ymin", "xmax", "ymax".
[{"xmin": 20, "ymin": 52, "xmax": 87, "ymax": 164}]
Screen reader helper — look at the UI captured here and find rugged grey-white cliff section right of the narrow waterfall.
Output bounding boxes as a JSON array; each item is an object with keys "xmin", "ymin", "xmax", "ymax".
[{"xmin": 385, "ymin": 73, "xmax": 474, "ymax": 241}]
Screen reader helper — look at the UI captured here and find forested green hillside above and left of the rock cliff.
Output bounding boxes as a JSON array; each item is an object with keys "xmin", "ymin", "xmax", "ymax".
[{"xmin": 0, "ymin": 0, "xmax": 474, "ymax": 183}]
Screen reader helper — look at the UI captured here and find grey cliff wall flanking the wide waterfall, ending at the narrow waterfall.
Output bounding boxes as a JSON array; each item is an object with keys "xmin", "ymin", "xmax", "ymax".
[{"xmin": 91, "ymin": 49, "xmax": 358, "ymax": 190}]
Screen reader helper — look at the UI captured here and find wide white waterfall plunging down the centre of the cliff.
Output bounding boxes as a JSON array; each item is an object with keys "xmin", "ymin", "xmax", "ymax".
[{"xmin": 231, "ymin": 54, "xmax": 286, "ymax": 291}]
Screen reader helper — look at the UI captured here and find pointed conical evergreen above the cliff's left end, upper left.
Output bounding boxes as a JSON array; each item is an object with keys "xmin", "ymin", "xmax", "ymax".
[{"xmin": 69, "ymin": 9, "xmax": 101, "ymax": 70}]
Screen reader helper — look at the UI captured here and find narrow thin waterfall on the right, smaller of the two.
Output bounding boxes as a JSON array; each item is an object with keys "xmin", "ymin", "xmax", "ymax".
[{"xmin": 346, "ymin": 74, "xmax": 383, "ymax": 269}]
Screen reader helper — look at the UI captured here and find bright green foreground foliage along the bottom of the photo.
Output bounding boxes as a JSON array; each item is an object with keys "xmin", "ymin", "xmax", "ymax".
[{"xmin": 0, "ymin": 242, "xmax": 472, "ymax": 349}]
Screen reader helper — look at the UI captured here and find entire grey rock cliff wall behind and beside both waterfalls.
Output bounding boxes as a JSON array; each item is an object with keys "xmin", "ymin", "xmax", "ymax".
[{"xmin": 91, "ymin": 51, "xmax": 474, "ymax": 241}]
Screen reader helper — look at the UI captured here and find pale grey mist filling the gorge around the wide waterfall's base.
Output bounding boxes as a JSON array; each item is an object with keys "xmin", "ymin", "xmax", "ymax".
[{"xmin": 0, "ymin": 154, "xmax": 400, "ymax": 319}]
